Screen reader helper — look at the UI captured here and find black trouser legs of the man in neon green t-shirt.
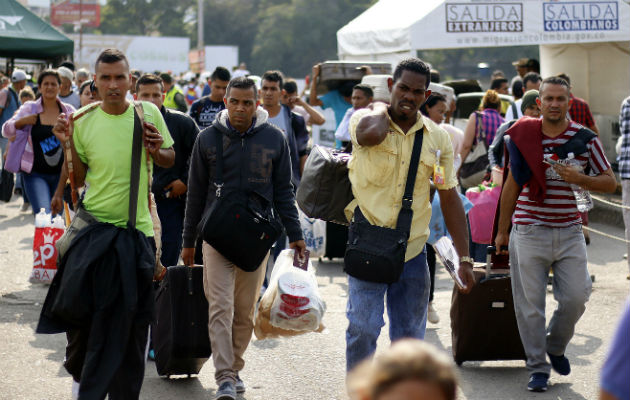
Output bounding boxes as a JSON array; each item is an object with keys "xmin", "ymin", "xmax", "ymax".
[{"xmin": 64, "ymin": 323, "xmax": 149, "ymax": 400}]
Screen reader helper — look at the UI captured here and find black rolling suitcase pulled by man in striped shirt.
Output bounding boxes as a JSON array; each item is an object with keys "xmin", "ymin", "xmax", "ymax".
[{"xmin": 451, "ymin": 246, "xmax": 526, "ymax": 365}]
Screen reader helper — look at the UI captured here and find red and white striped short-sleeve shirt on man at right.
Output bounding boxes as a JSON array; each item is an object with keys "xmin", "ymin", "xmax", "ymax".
[{"xmin": 514, "ymin": 122, "xmax": 610, "ymax": 228}]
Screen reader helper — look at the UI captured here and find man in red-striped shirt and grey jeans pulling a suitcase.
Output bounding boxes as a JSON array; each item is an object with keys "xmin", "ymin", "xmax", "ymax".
[{"xmin": 495, "ymin": 77, "xmax": 617, "ymax": 392}]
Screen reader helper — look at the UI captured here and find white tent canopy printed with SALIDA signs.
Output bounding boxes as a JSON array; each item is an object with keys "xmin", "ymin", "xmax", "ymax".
[{"xmin": 337, "ymin": 0, "xmax": 630, "ymax": 61}]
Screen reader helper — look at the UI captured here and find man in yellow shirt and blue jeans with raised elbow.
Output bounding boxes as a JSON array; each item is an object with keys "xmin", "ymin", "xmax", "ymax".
[{"xmin": 346, "ymin": 58, "xmax": 474, "ymax": 371}]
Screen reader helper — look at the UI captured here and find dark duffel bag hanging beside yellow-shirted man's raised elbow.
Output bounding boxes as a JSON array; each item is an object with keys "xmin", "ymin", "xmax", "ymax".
[{"xmin": 296, "ymin": 145, "xmax": 354, "ymax": 225}]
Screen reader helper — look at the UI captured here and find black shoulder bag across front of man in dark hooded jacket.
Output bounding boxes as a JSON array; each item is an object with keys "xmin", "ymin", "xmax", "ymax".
[{"xmin": 200, "ymin": 129, "xmax": 282, "ymax": 272}]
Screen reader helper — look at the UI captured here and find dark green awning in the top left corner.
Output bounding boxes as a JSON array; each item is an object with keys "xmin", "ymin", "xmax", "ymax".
[{"xmin": 0, "ymin": 0, "xmax": 74, "ymax": 60}]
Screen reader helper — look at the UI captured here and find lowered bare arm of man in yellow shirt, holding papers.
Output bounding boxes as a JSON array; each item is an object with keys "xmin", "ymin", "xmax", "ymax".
[{"xmin": 438, "ymin": 188, "xmax": 475, "ymax": 293}]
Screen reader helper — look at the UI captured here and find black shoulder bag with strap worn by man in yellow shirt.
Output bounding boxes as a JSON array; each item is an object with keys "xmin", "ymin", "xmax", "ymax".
[{"xmin": 344, "ymin": 130, "xmax": 423, "ymax": 284}]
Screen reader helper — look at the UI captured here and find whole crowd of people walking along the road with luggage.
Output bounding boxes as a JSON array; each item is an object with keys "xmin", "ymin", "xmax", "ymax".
[{"xmin": 0, "ymin": 49, "xmax": 630, "ymax": 400}]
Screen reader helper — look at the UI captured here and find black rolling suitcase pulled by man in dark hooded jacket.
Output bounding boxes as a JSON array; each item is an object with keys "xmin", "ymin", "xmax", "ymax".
[{"xmin": 151, "ymin": 266, "xmax": 211, "ymax": 377}]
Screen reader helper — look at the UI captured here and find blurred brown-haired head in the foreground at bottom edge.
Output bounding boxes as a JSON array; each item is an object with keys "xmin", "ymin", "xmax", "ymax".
[{"xmin": 348, "ymin": 339, "xmax": 457, "ymax": 400}]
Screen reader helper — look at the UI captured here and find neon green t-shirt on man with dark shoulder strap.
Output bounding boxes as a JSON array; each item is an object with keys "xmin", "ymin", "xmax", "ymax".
[{"xmin": 73, "ymin": 101, "xmax": 173, "ymax": 237}]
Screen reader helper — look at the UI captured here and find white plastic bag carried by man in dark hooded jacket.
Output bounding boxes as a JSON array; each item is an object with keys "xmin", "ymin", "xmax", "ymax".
[{"xmin": 254, "ymin": 250, "xmax": 326, "ymax": 339}]
